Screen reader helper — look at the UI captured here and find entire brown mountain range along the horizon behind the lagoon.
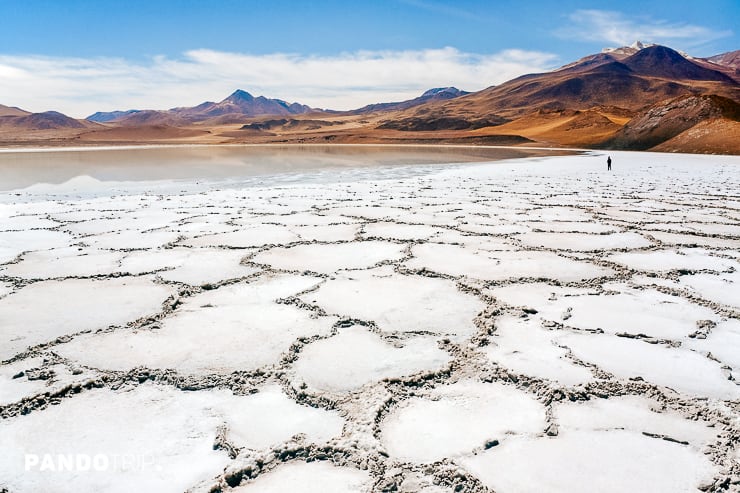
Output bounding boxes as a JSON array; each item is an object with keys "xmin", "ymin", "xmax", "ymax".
[{"xmin": 0, "ymin": 42, "xmax": 740, "ymax": 154}]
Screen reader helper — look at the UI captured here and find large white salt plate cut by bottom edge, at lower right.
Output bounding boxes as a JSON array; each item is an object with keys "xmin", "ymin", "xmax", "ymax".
[{"xmin": 460, "ymin": 431, "xmax": 716, "ymax": 493}]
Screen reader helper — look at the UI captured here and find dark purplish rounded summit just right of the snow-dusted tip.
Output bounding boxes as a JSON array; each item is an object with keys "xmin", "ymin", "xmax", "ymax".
[{"xmin": 623, "ymin": 45, "xmax": 734, "ymax": 83}]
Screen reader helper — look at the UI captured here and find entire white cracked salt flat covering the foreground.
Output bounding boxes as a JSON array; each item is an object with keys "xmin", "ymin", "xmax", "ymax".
[{"xmin": 0, "ymin": 152, "xmax": 740, "ymax": 493}]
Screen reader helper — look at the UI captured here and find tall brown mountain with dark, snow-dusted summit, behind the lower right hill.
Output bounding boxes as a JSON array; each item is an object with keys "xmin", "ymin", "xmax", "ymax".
[{"xmin": 398, "ymin": 46, "xmax": 740, "ymax": 119}]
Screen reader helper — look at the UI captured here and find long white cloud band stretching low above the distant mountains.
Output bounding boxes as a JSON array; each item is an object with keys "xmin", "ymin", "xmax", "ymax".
[{"xmin": 0, "ymin": 48, "xmax": 557, "ymax": 117}]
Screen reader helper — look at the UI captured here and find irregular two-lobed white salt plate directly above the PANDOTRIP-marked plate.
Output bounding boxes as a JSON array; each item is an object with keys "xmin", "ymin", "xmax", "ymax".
[{"xmin": 57, "ymin": 275, "xmax": 335, "ymax": 374}]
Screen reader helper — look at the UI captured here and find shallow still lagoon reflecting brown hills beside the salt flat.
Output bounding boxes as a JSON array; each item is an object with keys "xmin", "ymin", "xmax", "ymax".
[{"xmin": 0, "ymin": 145, "xmax": 564, "ymax": 191}]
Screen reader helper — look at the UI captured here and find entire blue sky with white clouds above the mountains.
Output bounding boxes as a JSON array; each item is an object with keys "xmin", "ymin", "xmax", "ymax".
[{"xmin": 0, "ymin": 0, "xmax": 740, "ymax": 116}]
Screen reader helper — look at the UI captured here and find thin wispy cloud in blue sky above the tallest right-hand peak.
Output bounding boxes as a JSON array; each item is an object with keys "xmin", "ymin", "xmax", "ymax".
[{"xmin": 555, "ymin": 10, "xmax": 732, "ymax": 48}]
